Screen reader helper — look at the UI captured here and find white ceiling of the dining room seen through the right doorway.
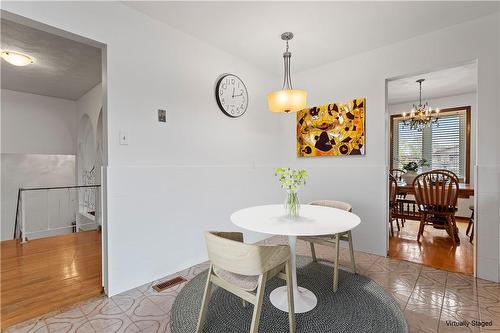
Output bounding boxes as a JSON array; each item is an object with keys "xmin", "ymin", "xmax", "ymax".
[{"xmin": 387, "ymin": 63, "xmax": 477, "ymax": 104}]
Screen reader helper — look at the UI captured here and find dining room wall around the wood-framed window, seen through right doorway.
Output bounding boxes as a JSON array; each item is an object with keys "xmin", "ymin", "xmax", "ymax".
[{"xmin": 388, "ymin": 93, "xmax": 477, "ymax": 217}]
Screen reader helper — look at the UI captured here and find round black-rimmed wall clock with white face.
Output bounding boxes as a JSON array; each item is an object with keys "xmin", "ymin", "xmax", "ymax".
[{"xmin": 215, "ymin": 74, "xmax": 248, "ymax": 118}]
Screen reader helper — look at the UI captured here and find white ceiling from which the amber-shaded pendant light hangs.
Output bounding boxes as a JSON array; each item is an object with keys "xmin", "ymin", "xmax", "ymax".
[{"xmin": 123, "ymin": 1, "xmax": 500, "ymax": 75}]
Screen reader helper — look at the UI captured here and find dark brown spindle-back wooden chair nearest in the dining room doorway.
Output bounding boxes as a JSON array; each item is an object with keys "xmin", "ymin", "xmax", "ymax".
[{"xmin": 413, "ymin": 170, "xmax": 460, "ymax": 245}]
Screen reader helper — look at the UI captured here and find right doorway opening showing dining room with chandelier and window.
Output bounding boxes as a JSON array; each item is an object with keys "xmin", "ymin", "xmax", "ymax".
[{"xmin": 387, "ymin": 62, "xmax": 477, "ymax": 275}]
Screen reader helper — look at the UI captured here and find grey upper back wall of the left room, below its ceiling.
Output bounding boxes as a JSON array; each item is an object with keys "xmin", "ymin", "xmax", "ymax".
[{"xmin": 1, "ymin": 89, "xmax": 77, "ymax": 155}]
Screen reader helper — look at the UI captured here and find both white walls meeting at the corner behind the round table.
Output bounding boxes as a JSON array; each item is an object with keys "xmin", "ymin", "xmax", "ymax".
[{"xmin": 3, "ymin": 2, "xmax": 500, "ymax": 295}]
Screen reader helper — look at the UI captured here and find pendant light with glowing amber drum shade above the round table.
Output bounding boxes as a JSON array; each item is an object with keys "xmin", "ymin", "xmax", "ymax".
[{"xmin": 267, "ymin": 32, "xmax": 307, "ymax": 112}]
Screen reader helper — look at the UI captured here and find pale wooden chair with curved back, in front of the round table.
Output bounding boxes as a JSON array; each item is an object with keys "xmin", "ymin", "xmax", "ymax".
[{"xmin": 196, "ymin": 232, "xmax": 295, "ymax": 333}]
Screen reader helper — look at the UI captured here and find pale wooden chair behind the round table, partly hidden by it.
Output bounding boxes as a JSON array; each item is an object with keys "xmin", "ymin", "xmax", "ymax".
[{"xmin": 298, "ymin": 200, "xmax": 356, "ymax": 292}]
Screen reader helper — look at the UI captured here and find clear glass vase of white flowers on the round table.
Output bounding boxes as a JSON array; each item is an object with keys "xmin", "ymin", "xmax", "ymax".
[{"xmin": 275, "ymin": 168, "xmax": 307, "ymax": 218}]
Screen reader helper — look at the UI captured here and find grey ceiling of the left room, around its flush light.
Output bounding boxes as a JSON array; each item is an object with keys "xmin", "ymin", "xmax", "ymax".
[{"xmin": 1, "ymin": 19, "xmax": 101, "ymax": 100}]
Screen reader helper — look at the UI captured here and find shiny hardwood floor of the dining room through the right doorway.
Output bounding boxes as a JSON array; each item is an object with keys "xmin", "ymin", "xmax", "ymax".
[{"xmin": 389, "ymin": 220, "xmax": 474, "ymax": 275}]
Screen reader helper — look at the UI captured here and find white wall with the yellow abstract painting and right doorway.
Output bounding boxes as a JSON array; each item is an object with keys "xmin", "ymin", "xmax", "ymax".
[{"xmin": 287, "ymin": 14, "xmax": 500, "ymax": 281}]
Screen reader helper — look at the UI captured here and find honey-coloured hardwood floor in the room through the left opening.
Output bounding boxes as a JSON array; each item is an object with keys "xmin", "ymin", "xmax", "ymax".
[{"xmin": 0, "ymin": 231, "xmax": 102, "ymax": 329}]
